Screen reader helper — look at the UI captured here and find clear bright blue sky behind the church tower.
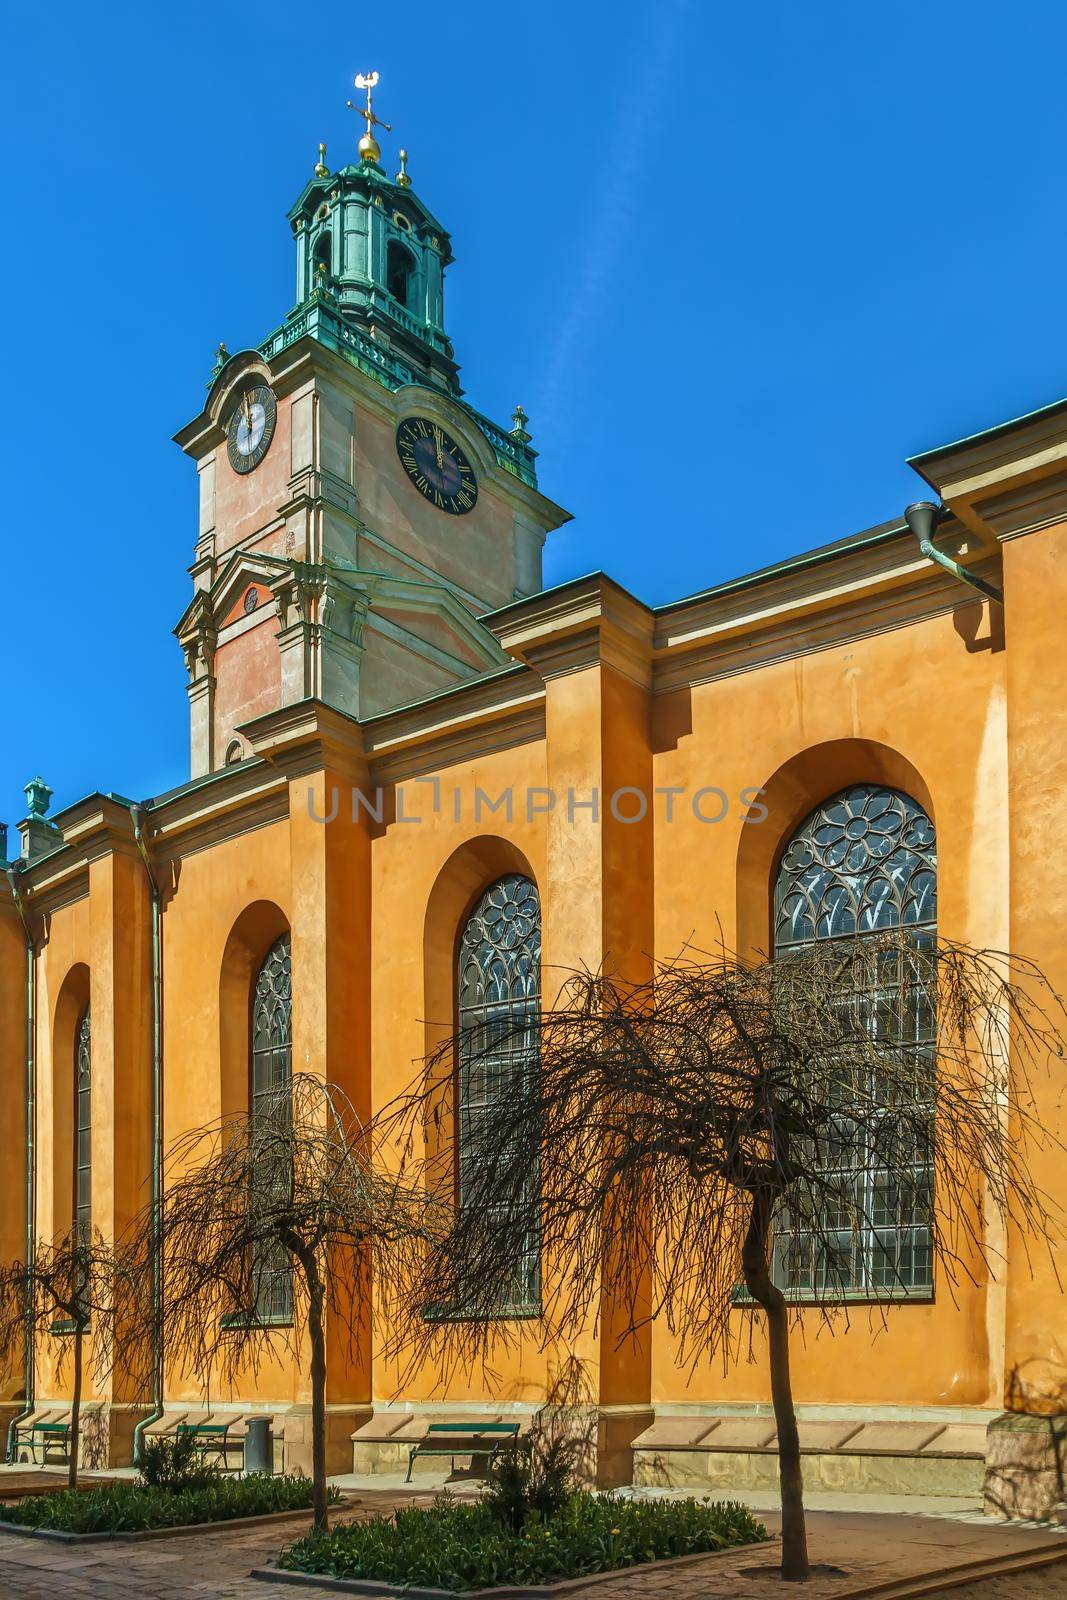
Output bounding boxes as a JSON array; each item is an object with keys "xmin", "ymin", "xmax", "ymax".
[{"xmin": 0, "ymin": 0, "xmax": 1067, "ymax": 822}]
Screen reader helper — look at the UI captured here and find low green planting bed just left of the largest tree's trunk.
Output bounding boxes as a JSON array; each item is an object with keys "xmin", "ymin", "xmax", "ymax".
[{"xmin": 278, "ymin": 1491, "xmax": 766, "ymax": 1590}]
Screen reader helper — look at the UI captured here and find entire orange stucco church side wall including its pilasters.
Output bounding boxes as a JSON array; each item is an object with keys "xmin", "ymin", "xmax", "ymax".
[{"xmin": 0, "ymin": 518, "xmax": 1067, "ymax": 1446}]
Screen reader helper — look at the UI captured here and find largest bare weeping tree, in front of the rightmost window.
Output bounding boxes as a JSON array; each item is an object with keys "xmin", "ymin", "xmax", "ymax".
[{"xmin": 382, "ymin": 931, "xmax": 1064, "ymax": 1579}]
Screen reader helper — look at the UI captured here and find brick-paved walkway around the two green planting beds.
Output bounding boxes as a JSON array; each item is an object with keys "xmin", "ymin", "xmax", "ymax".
[{"xmin": 0, "ymin": 1485, "xmax": 1067, "ymax": 1600}]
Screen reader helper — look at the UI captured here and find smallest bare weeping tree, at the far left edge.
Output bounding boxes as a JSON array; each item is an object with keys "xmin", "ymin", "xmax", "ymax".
[{"xmin": 0, "ymin": 1227, "xmax": 125, "ymax": 1488}]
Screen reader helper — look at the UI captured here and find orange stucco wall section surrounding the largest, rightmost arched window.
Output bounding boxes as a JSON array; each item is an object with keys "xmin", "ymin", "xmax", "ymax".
[{"xmin": 653, "ymin": 606, "xmax": 1008, "ymax": 1405}]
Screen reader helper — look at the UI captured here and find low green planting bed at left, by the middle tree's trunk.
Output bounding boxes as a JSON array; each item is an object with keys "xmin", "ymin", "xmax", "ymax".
[{"xmin": 3, "ymin": 1472, "xmax": 341, "ymax": 1533}]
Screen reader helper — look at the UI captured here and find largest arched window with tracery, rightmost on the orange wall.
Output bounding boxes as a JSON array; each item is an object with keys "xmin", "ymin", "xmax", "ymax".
[{"xmin": 774, "ymin": 784, "xmax": 937, "ymax": 1299}]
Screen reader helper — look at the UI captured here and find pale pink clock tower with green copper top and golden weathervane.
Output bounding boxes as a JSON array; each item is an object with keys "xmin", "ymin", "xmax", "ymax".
[{"xmin": 176, "ymin": 74, "xmax": 568, "ymax": 778}]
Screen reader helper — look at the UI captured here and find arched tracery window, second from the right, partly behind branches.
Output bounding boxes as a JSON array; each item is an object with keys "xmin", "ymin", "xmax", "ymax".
[{"xmin": 456, "ymin": 872, "xmax": 541, "ymax": 1315}]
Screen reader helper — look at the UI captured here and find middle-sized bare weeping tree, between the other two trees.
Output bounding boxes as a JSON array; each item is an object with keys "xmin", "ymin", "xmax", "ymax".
[{"xmin": 136, "ymin": 1074, "xmax": 432, "ymax": 1528}]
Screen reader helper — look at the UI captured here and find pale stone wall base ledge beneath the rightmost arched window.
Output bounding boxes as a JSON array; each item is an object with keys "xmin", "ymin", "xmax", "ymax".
[{"xmin": 633, "ymin": 1450, "xmax": 985, "ymax": 1498}]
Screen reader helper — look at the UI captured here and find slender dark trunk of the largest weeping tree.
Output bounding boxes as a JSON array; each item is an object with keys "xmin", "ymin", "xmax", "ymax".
[{"xmin": 742, "ymin": 1194, "xmax": 811, "ymax": 1582}]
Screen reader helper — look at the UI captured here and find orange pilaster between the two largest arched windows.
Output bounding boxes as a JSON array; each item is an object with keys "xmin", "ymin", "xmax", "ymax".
[{"xmin": 494, "ymin": 576, "xmax": 654, "ymax": 1485}]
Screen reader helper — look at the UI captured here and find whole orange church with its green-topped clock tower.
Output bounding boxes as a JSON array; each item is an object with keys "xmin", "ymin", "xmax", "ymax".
[{"xmin": 0, "ymin": 75, "xmax": 1067, "ymax": 1494}]
